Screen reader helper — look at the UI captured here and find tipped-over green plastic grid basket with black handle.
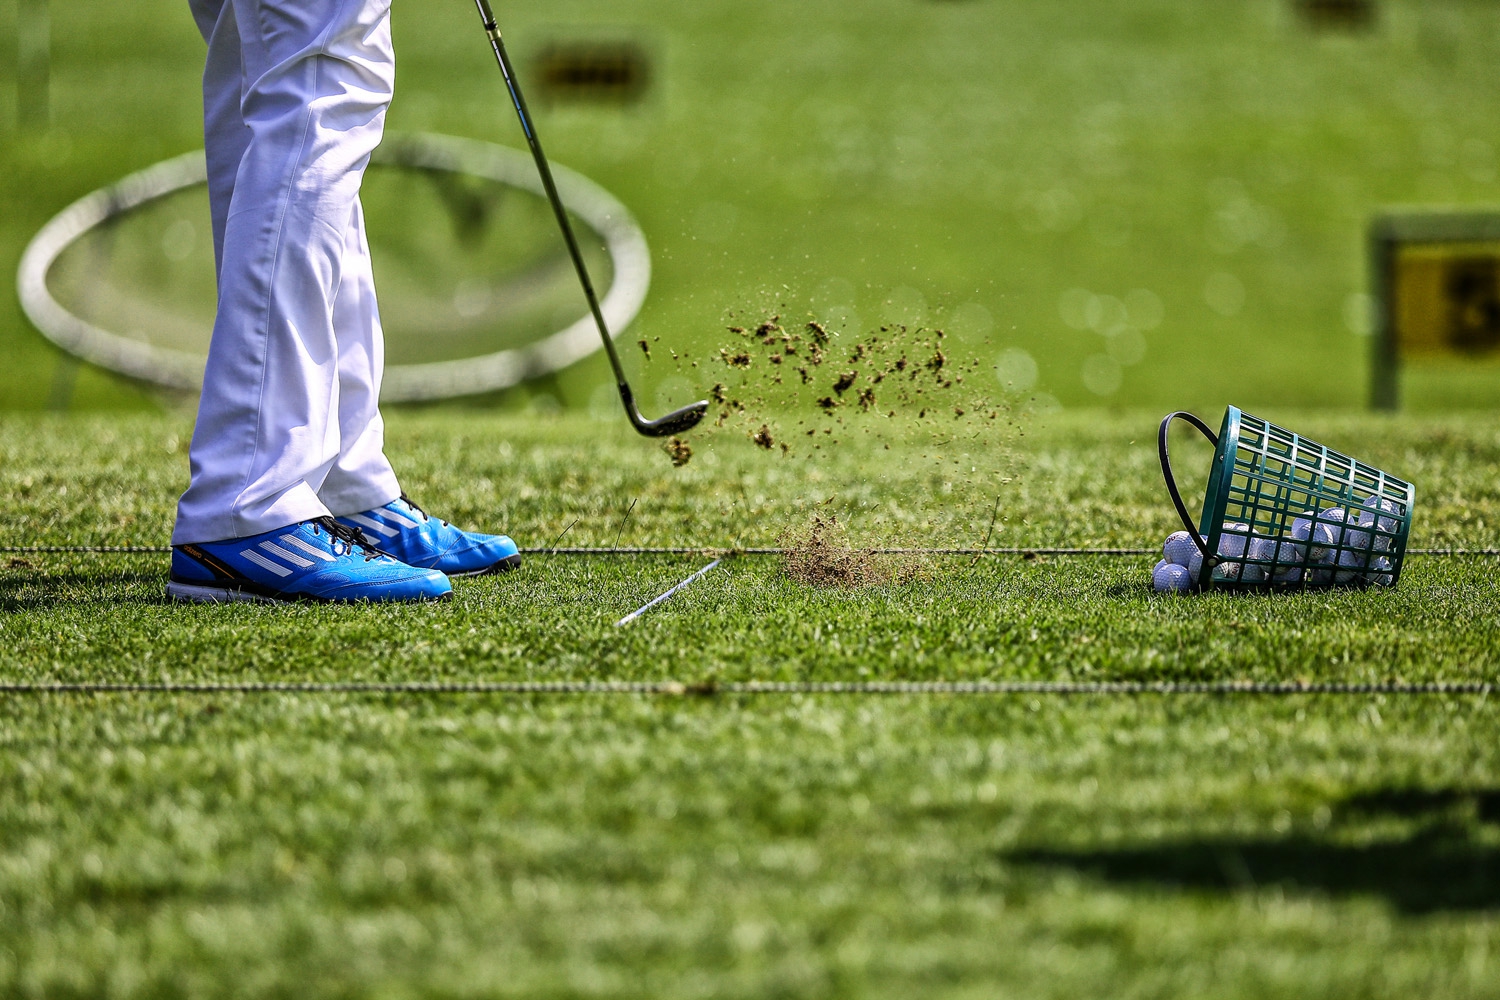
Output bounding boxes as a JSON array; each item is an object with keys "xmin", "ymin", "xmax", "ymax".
[{"xmin": 1157, "ymin": 406, "xmax": 1416, "ymax": 591}]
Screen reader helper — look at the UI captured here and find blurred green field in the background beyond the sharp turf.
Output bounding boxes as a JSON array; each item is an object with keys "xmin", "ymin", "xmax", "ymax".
[{"xmin": 0, "ymin": 0, "xmax": 1500, "ymax": 412}]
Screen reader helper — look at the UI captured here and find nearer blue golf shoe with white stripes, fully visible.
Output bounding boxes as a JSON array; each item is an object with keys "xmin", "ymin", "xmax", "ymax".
[{"xmin": 167, "ymin": 517, "xmax": 453, "ymax": 603}]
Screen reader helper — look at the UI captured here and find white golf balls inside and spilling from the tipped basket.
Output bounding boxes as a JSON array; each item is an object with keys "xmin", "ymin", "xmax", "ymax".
[{"xmin": 1151, "ymin": 496, "xmax": 1401, "ymax": 594}]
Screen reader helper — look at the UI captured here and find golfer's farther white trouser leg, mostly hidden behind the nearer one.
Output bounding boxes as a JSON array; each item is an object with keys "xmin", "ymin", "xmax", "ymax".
[{"xmin": 318, "ymin": 201, "xmax": 401, "ymax": 516}]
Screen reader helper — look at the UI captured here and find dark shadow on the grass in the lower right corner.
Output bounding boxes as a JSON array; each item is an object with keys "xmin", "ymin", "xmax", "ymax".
[{"xmin": 1002, "ymin": 789, "xmax": 1500, "ymax": 913}]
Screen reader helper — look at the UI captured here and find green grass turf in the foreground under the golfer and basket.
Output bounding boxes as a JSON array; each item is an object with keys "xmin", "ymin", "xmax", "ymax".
[{"xmin": 0, "ymin": 414, "xmax": 1500, "ymax": 997}]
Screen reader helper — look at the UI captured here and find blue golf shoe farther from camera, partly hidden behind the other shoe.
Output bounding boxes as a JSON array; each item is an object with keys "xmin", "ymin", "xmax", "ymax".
[{"xmin": 339, "ymin": 495, "xmax": 521, "ymax": 576}]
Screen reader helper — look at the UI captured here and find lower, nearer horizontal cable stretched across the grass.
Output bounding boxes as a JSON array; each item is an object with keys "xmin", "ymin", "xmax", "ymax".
[{"xmin": 0, "ymin": 681, "xmax": 1496, "ymax": 697}]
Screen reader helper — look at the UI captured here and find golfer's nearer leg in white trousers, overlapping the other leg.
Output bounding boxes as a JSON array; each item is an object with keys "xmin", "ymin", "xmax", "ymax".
[{"xmin": 173, "ymin": 0, "xmax": 395, "ymax": 544}]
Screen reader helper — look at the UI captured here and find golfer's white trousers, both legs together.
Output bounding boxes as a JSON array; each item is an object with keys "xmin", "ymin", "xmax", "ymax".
[{"xmin": 173, "ymin": 0, "xmax": 401, "ymax": 544}]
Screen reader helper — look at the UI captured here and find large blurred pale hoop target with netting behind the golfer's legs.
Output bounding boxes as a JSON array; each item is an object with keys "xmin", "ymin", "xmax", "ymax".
[{"xmin": 17, "ymin": 135, "xmax": 651, "ymax": 402}]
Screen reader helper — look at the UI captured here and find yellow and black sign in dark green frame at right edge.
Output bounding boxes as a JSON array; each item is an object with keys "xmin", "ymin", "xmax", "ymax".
[{"xmin": 1370, "ymin": 211, "xmax": 1500, "ymax": 409}]
